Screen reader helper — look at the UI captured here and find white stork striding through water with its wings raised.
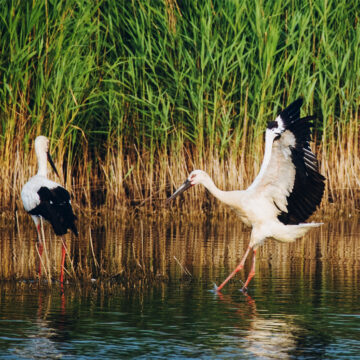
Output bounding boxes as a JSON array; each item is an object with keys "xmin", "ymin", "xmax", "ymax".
[{"xmin": 167, "ymin": 98, "xmax": 325, "ymax": 291}]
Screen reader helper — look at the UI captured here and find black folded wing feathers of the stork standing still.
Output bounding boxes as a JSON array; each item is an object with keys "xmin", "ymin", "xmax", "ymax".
[{"xmin": 29, "ymin": 186, "xmax": 78, "ymax": 236}]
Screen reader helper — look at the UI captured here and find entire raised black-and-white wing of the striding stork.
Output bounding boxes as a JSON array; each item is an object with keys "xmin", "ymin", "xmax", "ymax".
[{"xmin": 249, "ymin": 98, "xmax": 325, "ymax": 224}]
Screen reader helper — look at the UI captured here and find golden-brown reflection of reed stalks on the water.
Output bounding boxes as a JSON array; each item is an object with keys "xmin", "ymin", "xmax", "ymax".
[{"xmin": 0, "ymin": 217, "xmax": 360, "ymax": 287}]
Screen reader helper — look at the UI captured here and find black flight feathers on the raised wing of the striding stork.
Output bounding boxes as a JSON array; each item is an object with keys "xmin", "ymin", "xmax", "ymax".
[{"xmin": 278, "ymin": 98, "xmax": 325, "ymax": 225}]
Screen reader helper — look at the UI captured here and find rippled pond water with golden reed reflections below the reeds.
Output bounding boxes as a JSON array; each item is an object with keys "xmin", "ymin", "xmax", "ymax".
[{"xmin": 0, "ymin": 215, "xmax": 360, "ymax": 359}]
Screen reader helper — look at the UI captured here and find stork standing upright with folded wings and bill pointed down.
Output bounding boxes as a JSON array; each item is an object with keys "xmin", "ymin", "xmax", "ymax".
[{"xmin": 21, "ymin": 136, "xmax": 78, "ymax": 283}]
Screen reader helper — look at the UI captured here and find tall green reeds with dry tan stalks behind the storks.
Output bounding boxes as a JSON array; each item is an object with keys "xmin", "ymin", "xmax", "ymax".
[{"xmin": 0, "ymin": 0, "xmax": 360, "ymax": 214}]
